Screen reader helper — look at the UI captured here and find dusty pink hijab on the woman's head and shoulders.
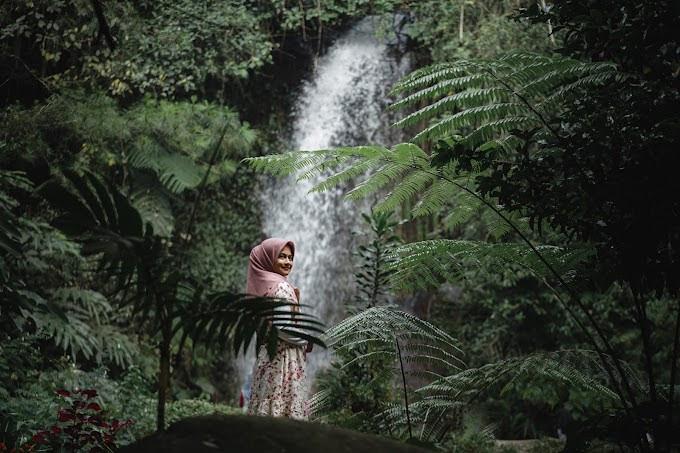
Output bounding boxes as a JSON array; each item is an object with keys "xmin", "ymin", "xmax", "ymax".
[{"xmin": 246, "ymin": 238, "xmax": 295, "ymax": 296}]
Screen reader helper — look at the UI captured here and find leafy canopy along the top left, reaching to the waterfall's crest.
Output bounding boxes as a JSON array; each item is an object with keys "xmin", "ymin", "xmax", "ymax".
[{"xmin": 0, "ymin": 0, "xmax": 399, "ymax": 99}]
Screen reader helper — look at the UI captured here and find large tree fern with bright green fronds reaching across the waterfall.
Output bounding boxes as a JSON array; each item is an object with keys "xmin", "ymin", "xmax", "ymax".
[{"xmin": 249, "ymin": 53, "xmax": 636, "ymax": 407}]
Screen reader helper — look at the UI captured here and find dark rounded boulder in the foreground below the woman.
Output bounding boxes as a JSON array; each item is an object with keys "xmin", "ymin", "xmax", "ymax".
[{"xmin": 119, "ymin": 415, "xmax": 428, "ymax": 453}]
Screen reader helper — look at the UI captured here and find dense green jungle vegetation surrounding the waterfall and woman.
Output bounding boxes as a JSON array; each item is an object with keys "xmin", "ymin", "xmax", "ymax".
[{"xmin": 0, "ymin": 0, "xmax": 680, "ymax": 452}]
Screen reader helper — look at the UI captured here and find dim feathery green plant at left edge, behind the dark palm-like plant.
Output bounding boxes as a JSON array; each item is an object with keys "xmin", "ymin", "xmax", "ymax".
[{"xmin": 0, "ymin": 171, "xmax": 137, "ymax": 367}]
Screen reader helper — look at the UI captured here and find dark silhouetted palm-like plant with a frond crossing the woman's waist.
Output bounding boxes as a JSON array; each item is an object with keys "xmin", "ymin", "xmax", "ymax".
[{"xmin": 40, "ymin": 167, "xmax": 323, "ymax": 430}]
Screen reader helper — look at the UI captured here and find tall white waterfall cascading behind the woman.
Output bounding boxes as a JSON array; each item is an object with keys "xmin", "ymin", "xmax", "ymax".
[{"xmin": 244, "ymin": 18, "xmax": 408, "ymax": 400}]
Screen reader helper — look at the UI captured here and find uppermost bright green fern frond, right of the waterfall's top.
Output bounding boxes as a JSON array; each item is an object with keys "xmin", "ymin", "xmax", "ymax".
[{"xmin": 393, "ymin": 53, "xmax": 622, "ymax": 148}]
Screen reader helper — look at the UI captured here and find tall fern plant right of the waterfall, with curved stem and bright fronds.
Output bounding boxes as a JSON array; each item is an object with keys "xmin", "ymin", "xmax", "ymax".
[{"xmin": 248, "ymin": 53, "xmax": 672, "ymax": 449}]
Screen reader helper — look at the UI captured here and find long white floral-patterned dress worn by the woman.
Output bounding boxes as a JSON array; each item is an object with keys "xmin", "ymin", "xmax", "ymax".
[{"xmin": 248, "ymin": 282, "xmax": 307, "ymax": 420}]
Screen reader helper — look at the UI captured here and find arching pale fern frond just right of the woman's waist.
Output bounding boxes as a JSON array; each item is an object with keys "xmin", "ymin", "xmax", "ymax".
[{"xmin": 325, "ymin": 307, "xmax": 465, "ymax": 376}]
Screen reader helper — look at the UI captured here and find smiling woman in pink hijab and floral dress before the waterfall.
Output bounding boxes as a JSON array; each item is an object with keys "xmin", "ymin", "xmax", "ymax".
[{"xmin": 246, "ymin": 238, "xmax": 311, "ymax": 420}]
